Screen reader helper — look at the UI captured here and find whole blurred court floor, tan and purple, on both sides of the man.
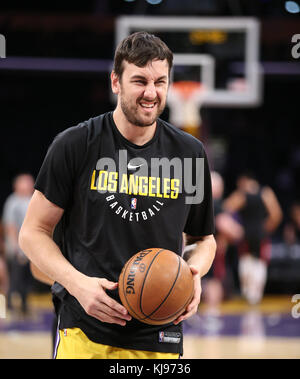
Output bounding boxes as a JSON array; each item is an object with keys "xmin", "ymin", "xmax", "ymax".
[{"xmin": 0, "ymin": 295, "xmax": 300, "ymax": 359}]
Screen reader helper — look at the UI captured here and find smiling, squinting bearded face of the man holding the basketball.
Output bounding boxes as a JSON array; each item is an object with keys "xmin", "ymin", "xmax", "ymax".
[{"xmin": 112, "ymin": 60, "xmax": 169, "ymax": 127}]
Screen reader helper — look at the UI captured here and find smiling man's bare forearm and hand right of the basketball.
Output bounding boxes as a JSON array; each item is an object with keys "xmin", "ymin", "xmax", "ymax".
[{"xmin": 174, "ymin": 234, "xmax": 217, "ymax": 325}]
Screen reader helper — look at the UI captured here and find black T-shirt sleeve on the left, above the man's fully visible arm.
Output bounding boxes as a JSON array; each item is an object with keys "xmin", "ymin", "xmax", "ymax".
[{"xmin": 35, "ymin": 124, "xmax": 87, "ymax": 209}]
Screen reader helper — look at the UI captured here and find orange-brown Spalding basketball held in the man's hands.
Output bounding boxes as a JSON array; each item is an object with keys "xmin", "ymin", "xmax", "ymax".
[{"xmin": 119, "ymin": 248, "xmax": 194, "ymax": 325}]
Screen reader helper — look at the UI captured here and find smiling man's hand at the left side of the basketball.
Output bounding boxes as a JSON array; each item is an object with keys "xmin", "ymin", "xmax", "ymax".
[{"xmin": 72, "ymin": 276, "xmax": 131, "ymax": 326}]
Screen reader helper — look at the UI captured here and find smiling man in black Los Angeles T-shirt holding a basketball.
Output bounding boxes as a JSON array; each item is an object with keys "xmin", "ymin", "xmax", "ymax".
[{"xmin": 19, "ymin": 32, "xmax": 216, "ymax": 358}]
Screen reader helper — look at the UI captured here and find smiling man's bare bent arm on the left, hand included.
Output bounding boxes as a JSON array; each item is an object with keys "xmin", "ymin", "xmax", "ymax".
[{"xmin": 19, "ymin": 191, "xmax": 131, "ymax": 325}]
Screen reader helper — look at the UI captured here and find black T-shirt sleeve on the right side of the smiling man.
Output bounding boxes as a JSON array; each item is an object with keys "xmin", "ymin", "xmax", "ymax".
[{"xmin": 184, "ymin": 147, "xmax": 215, "ymax": 236}]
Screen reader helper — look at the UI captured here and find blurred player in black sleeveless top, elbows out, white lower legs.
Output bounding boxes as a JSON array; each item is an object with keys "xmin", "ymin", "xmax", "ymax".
[{"xmin": 223, "ymin": 173, "xmax": 282, "ymax": 304}]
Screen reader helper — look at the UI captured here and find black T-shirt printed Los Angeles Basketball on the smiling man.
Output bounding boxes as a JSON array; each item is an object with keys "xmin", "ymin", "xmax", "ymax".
[{"xmin": 35, "ymin": 112, "xmax": 214, "ymax": 353}]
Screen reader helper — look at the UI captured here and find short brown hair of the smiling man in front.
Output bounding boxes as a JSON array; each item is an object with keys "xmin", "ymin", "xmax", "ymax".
[{"xmin": 113, "ymin": 31, "xmax": 173, "ymax": 78}]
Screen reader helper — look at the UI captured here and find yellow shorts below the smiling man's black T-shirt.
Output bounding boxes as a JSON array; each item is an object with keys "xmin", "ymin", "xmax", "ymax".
[{"xmin": 54, "ymin": 328, "xmax": 179, "ymax": 359}]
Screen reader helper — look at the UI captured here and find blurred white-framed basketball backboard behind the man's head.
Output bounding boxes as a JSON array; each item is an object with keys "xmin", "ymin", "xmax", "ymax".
[{"xmin": 116, "ymin": 16, "xmax": 262, "ymax": 107}]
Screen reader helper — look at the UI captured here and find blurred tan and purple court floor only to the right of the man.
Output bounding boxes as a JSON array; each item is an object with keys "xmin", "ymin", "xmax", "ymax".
[{"xmin": 180, "ymin": 296, "xmax": 300, "ymax": 359}]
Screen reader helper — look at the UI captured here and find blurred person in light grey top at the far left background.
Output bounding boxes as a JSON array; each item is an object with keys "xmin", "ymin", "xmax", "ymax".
[{"xmin": 2, "ymin": 173, "xmax": 34, "ymax": 315}]
